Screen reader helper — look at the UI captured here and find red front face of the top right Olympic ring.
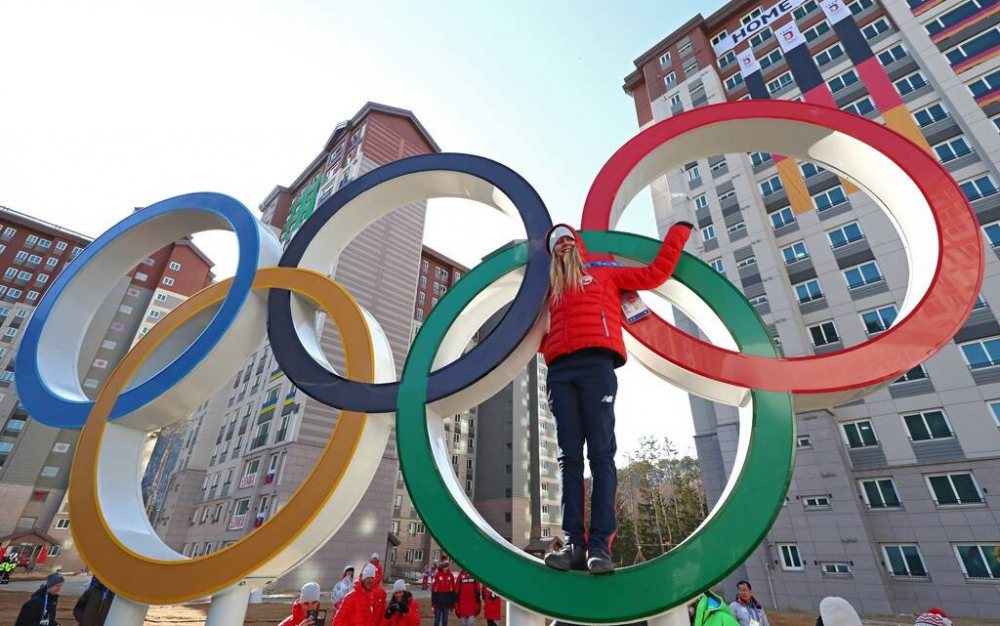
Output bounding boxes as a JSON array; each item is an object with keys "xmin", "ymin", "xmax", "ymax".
[{"xmin": 581, "ymin": 100, "xmax": 984, "ymax": 394}]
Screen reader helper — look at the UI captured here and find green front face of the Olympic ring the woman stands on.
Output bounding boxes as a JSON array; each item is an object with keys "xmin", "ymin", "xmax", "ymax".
[{"xmin": 396, "ymin": 231, "xmax": 795, "ymax": 623}]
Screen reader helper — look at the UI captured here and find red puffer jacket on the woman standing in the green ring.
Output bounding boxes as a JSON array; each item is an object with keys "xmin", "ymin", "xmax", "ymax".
[{"xmin": 541, "ymin": 222, "xmax": 691, "ymax": 367}]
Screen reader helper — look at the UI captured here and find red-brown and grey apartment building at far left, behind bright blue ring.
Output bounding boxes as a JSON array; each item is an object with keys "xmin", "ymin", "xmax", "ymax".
[{"xmin": 0, "ymin": 208, "xmax": 212, "ymax": 571}]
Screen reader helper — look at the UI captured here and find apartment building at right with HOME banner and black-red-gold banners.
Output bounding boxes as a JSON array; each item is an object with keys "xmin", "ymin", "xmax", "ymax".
[{"xmin": 624, "ymin": 0, "xmax": 1000, "ymax": 617}]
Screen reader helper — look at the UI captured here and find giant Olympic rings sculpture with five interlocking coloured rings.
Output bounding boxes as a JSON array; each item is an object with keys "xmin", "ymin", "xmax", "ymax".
[{"xmin": 17, "ymin": 101, "xmax": 983, "ymax": 623}]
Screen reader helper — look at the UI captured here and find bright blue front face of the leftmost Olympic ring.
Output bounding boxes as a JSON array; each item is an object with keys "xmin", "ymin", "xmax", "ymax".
[{"xmin": 16, "ymin": 192, "xmax": 261, "ymax": 429}]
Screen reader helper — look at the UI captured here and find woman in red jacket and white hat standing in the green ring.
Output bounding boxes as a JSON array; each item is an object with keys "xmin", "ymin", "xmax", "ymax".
[{"xmin": 541, "ymin": 222, "xmax": 693, "ymax": 574}]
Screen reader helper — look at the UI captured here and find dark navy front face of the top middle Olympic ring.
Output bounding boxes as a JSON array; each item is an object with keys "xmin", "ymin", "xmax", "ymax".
[{"xmin": 267, "ymin": 153, "xmax": 552, "ymax": 413}]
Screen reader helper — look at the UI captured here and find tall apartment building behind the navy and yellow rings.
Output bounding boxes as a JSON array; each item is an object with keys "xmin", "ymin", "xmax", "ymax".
[{"xmin": 154, "ymin": 103, "xmax": 439, "ymax": 589}]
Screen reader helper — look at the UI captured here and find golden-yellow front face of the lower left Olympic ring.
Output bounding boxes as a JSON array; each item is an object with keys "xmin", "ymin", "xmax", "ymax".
[{"xmin": 69, "ymin": 267, "xmax": 375, "ymax": 604}]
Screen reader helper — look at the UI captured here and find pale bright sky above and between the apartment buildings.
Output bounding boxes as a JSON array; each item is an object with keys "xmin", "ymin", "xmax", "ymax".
[{"xmin": 0, "ymin": 0, "xmax": 722, "ymax": 462}]
